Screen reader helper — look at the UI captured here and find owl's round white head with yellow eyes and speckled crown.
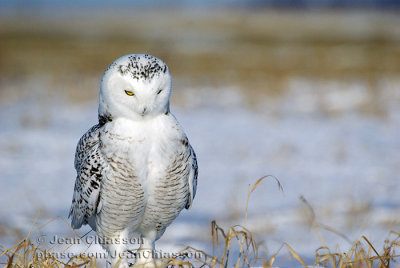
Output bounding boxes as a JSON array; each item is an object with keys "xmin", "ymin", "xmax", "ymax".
[{"xmin": 99, "ymin": 54, "xmax": 172, "ymax": 120}]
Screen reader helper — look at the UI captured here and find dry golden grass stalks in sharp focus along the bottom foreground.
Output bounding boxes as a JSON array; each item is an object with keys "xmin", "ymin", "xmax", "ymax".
[{"xmin": 0, "ymin": 177, "xmax": 400, "ymax": 268}]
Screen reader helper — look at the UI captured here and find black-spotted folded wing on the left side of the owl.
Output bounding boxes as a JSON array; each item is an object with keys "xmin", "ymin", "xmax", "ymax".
[{"xmin": 68, "ymin": 125, "xmax": 106, "ymax": 229}]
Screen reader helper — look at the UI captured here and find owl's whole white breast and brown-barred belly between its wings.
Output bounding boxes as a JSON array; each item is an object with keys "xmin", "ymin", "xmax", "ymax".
[{"xmin": 95, "ymin": 115, "xmax": 188, "ymax": 234}]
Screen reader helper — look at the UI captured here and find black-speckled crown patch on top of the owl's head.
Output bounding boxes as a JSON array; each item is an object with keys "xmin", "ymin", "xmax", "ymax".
[{"xmin": 112, "ymin": 54, "xmax": 168, "ymax": 80}]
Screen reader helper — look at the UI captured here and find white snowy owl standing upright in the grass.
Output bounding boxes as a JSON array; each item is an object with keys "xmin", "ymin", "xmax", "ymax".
[{"xmin": 69, "ymin": 54, "xmax": 197, "ymax": 267}]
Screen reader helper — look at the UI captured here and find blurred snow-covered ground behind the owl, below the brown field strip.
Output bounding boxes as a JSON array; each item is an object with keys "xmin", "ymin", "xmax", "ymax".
[{"xmin": 0, "ymin": 79, "xmax": 400, "ymax": 263}]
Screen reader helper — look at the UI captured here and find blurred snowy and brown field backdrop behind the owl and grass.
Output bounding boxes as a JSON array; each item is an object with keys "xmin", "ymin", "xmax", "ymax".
[{"xmin": 0, "ymin": 0, "xmax": 400, "ymax": 266}]
